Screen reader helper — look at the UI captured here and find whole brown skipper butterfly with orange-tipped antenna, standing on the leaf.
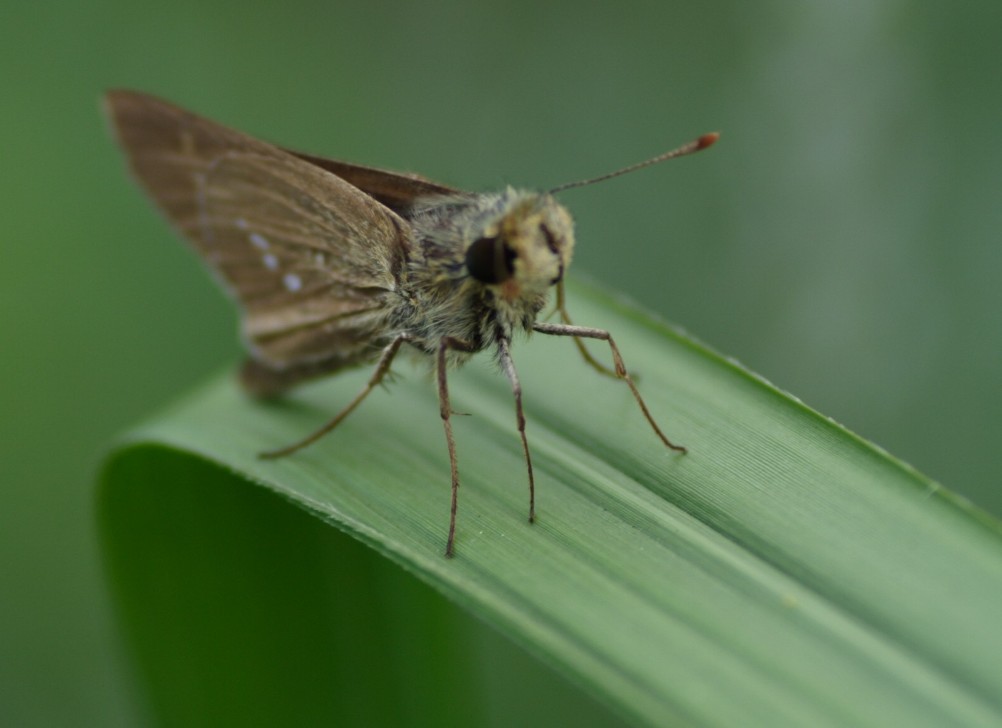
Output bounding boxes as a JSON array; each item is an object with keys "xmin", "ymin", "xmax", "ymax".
[{"xmin": 105, "ymin": 90, "xmax": 717, "ymax": 556}]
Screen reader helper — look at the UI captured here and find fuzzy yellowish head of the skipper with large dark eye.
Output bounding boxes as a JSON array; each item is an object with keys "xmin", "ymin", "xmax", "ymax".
[{"xmin": 466, "ymin": 189, "xmax": 574, "ymax": 300}]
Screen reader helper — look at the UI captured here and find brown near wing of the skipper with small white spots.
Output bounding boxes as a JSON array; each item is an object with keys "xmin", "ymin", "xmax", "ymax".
[{"xmin": 106, "ymin": 91, "xmax": 410, "ymax": 389}]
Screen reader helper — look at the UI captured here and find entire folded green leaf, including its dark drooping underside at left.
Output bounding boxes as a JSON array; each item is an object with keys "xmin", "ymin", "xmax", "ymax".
[{"xmin": 100, "ymin": 286, "xmax": 1002, "ymax": 726}]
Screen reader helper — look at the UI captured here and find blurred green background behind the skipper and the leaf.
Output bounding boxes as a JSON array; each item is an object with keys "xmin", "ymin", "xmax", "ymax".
[{"xmin": 0, "ymin": 0, "xmax": 1002, "ymax": 726}]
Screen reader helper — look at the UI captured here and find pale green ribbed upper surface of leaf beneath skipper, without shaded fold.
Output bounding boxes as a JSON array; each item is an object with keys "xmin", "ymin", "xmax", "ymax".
[{"xmin": 103, "ymin": 280, "xmax": 1002, "ymax": 726}]
